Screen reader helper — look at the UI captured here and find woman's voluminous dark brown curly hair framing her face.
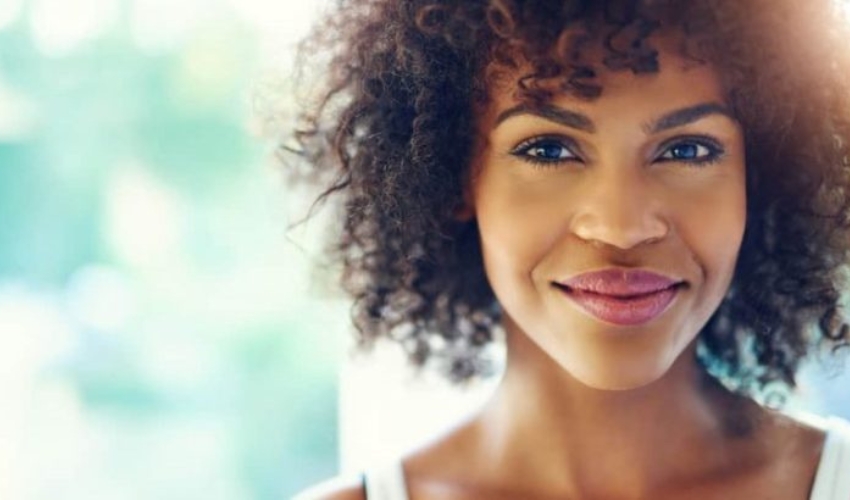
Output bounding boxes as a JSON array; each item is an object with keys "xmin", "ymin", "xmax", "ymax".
[{"xmin": 288, "ymin": 0, "xmax": 850, "ymax": 394}]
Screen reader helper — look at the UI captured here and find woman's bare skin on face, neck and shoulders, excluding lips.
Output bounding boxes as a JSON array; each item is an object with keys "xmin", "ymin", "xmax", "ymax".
[{"xmin": 304, "ymin": 40, "xmax": 823, "ymax": 500}]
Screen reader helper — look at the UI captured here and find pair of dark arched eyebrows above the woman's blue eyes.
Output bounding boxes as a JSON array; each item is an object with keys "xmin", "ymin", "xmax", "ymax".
[{"xmin": 495, "ymin": 102, "xmax": 737, "ymax": 134}]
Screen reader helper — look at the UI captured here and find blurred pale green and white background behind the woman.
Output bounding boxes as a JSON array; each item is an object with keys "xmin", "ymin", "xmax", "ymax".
[{"xmin": 0, "ymin": 0, "xmax": 850, "ymax": 500}]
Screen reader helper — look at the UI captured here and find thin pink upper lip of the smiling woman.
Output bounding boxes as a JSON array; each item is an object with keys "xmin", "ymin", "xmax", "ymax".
[{"xmin": 556, "ymin": 268, "xmax": 683, "ymax": 297}]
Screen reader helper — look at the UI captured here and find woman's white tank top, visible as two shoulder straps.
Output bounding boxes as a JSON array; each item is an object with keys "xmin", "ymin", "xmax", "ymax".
[{"xmin": 363, "ymin": 418, "xmax": 850, "ymax": 500}]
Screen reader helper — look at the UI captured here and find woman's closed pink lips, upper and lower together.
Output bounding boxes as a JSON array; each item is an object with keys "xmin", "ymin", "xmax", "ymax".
[{"xmin": 555, "ymin": 268, "xmax": 684, "ymax": 325}]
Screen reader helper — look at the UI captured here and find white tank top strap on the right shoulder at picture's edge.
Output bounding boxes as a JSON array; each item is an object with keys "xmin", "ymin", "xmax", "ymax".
[{"xmin": 809, "ymin": 417, "xmax": 850, "ymax": 500}]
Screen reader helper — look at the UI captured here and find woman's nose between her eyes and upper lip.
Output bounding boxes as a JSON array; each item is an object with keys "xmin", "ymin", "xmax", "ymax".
[{"xmin": 570, "ymin": 169, "xmax": 670, "ymax": 250}]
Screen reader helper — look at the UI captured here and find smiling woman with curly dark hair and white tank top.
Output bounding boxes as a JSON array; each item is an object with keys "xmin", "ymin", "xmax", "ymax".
[{"xmin": 288, "ymin": 0, "xmax": 850, "ymax": 500}]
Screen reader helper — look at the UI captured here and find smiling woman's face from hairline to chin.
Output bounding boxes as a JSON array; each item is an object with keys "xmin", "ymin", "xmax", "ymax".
[{"xmin": 470, "ymin": 44, "xmax": 746, "ymax": 389}]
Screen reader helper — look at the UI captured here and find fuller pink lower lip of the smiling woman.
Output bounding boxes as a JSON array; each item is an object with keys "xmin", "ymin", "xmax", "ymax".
[{"xmin": 559, "ymin": 286, "xmax": 679, "ymax": 326}]
